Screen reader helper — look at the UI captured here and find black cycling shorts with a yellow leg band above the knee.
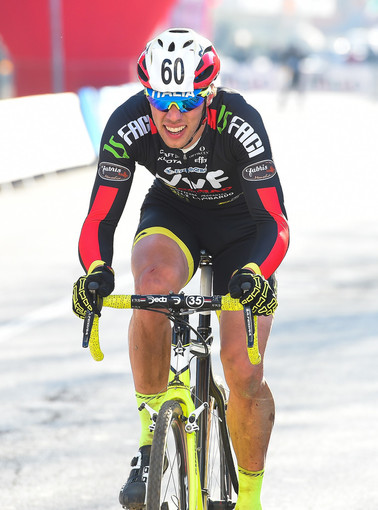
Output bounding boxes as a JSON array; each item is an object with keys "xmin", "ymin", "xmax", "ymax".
[{"xmin": 134, "ymin": 188, "xmax": 276, "ymax": 295}]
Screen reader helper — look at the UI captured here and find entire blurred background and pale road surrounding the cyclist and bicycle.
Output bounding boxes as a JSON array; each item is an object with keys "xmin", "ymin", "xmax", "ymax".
[{"xmin": 0, "ymin": 0, "xmax": 378, "ymax": 510}]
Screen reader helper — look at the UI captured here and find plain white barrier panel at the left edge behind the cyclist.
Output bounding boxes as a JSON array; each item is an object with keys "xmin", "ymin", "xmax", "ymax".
[{"xmin": 0, "ymin": 93, "xmax": 96, "ymax": 184}]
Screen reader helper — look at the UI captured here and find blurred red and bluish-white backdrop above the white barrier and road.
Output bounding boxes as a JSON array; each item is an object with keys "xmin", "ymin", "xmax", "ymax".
[{"xmin": 0, "ymin": 0, "xmax": 378, "ymax": 98}]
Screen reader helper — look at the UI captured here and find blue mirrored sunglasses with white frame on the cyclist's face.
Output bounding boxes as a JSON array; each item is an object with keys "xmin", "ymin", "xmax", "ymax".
[{"xmin": 146, "ymin": 87, "xmax": 210, "ymax": 113}]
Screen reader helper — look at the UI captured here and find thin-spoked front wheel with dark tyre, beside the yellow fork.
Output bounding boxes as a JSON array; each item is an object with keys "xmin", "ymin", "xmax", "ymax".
[{"xmin": 147, "ymin": 400, "xmax": 189, "ymax": 510}]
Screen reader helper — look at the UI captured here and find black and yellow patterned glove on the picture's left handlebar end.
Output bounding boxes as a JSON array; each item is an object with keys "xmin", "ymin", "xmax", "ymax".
[{"xmin": 72, "ymin": 260, "xmax": 114, "ymax": 319}]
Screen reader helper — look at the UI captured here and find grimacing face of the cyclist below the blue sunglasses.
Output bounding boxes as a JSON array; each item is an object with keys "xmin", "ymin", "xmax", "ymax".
[{"xmin": 150, "ymin": 103, "xmax": 205, "ymax": 149}]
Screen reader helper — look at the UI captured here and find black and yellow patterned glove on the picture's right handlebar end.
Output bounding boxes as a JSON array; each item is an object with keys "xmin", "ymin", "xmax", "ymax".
[{"xmin": 228, "ymin": 264, "xmax": 278, "ymax": 315}]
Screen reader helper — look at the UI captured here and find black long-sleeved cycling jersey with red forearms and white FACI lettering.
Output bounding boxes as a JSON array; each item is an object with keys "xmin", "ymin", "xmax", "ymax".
[{"xmin": 79, "ymin": 88, "xmax": 289, "ymax": 277}]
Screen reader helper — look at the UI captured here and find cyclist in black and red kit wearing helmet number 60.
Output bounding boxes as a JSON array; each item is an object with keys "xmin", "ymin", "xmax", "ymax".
[{"xmin": 73, "ymin": 29, "xmax": 289, "ymax": 510}]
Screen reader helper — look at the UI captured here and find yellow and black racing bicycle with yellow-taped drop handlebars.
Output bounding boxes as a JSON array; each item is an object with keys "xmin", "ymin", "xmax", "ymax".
[{"xmin": 83, "ymin": 252, "xmax": 261, "ymax": 510}]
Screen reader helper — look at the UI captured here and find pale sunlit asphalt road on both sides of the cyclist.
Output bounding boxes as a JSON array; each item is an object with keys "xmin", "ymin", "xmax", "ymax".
[{"xmin": 0, "ymin": 89, "xmax": 378, "ymax": 510}]
